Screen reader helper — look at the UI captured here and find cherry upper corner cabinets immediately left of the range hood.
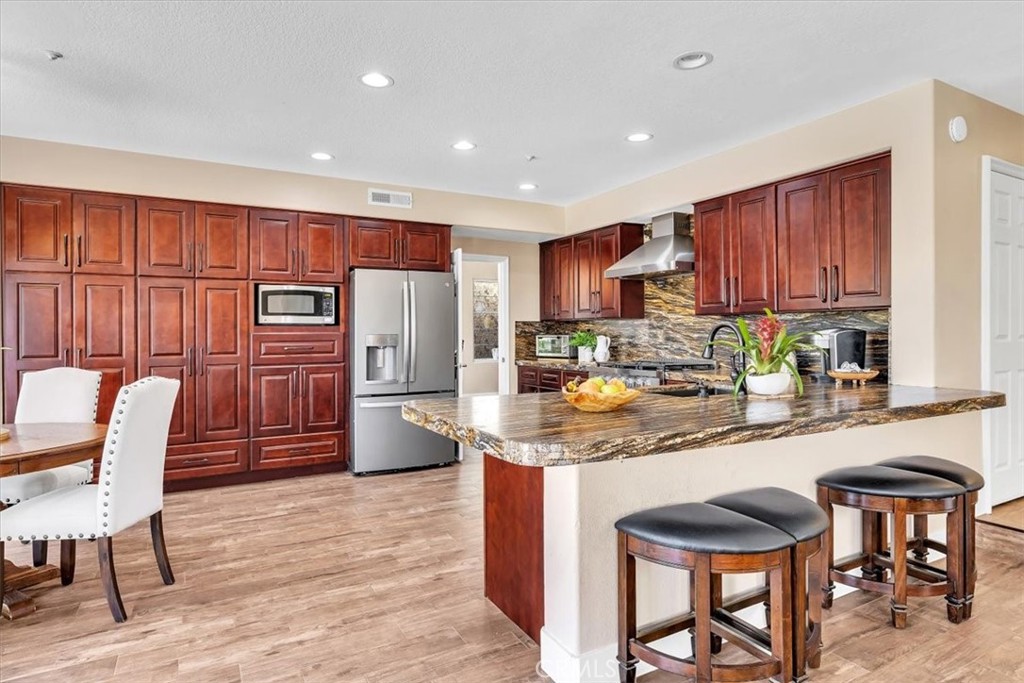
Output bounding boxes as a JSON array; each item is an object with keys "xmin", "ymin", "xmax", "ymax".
[{"xmin": 541, "ymin": 223, "xmax": 643, "ymax": 321}]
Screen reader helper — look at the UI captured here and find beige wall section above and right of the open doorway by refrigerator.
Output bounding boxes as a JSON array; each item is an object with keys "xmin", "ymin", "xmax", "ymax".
[{"xmin": 452, "ymin": 238, "xmax": 541, "ymax": 391}]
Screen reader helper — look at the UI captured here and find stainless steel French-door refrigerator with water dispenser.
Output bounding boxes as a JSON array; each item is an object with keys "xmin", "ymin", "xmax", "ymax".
[{"xmin": 349, "ymin": 268, "xmax": 458, "ymax": 474}]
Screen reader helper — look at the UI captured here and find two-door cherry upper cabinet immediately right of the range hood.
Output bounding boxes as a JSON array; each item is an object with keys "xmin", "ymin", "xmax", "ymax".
[{"xmin": 694, "ymin": 185, "xmax": 775, "ymax": 314}]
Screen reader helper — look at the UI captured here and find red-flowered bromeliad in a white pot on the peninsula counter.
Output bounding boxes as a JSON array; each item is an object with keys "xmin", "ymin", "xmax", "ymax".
[{"xmin": 713, "ymin": 308, "xmax": 817, "ymax": 396}]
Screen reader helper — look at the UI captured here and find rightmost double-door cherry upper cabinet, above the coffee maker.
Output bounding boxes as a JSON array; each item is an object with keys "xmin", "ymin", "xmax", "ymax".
[{"xmin": 776, "ymin": 156, "xmax": 891, "ymax": 311}]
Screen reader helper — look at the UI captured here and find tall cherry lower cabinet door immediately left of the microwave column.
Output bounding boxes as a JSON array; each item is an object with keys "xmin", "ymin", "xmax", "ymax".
[{"xmin": 196, "ymin": 280, "xmax": 251, "ymax": 441}]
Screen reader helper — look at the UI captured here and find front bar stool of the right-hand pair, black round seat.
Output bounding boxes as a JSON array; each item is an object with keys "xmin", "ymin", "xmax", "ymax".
[{"xmin": 817, "ymin": 465, "xmax": 966, "ymax": 629}]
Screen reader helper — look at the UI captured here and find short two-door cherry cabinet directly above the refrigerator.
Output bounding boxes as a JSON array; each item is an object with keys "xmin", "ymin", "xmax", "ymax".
[{"xmin": 348, "ymin": 218, "xmax": 452, "ymax": 270}]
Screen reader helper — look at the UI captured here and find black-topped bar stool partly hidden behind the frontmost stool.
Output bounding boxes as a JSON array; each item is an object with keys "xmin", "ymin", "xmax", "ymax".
[{"xmin": 707, "ymin": 486, "xmax": 828, "ymax": 681}]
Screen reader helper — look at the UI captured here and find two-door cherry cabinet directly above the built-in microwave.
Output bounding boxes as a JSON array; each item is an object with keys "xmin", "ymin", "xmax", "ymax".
[{"xmin": 249, "ymin": 210, "xmax": 345, "ymax": 283}]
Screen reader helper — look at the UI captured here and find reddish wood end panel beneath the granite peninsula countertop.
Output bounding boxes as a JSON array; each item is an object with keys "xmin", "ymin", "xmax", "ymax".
[{"xmin": 483, "ymin": 454, "xmax": 544, "ymax": 643}]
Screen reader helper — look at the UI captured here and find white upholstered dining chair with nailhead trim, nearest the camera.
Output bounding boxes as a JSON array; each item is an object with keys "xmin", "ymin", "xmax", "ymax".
[{"xmin": 0, "ymin": 377, "xmax": 180, "ymax": 622}]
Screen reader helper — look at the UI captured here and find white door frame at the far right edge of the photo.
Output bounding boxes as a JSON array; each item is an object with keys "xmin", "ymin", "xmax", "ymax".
[{"xmin": 978, "ymin": 155, "xmax": 1024, "ymax": 514}]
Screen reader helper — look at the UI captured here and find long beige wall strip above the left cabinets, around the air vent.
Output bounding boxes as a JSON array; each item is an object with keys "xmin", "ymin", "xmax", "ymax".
[{"xmin": 0, "ymin": 137, "xmax": 564, "ymax": 233}]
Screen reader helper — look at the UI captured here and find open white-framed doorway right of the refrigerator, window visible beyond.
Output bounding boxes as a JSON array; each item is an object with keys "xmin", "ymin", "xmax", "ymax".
[{"xmin": 452, "ymin": 249, "xmax": 511, "ymax": 396}]
